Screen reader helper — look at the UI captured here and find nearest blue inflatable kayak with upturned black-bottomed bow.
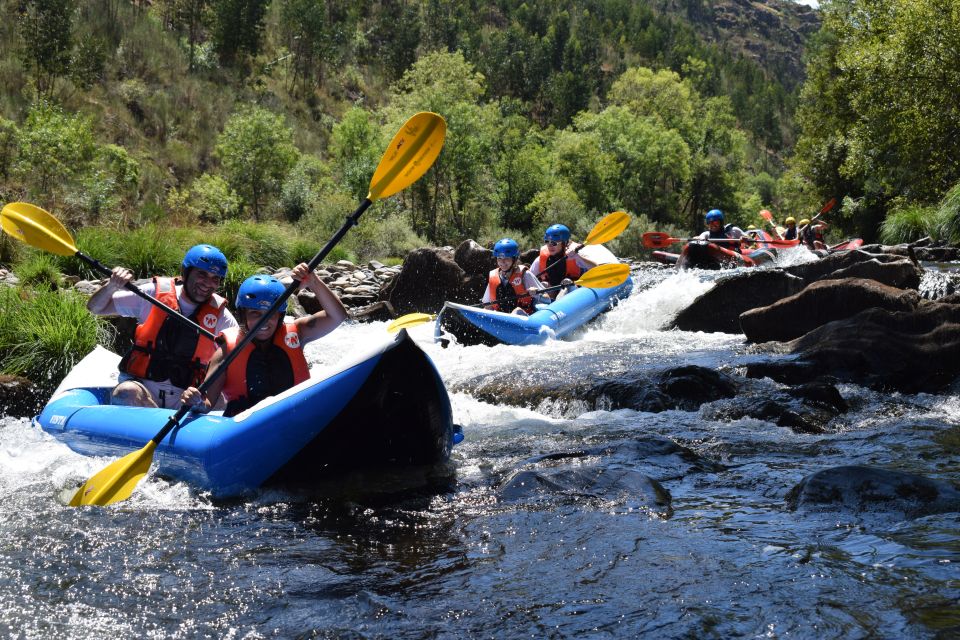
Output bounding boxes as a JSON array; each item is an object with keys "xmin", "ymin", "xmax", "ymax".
[{"xmin": 34, "ymin": 331, "xmax": 462, "ymax": 498}]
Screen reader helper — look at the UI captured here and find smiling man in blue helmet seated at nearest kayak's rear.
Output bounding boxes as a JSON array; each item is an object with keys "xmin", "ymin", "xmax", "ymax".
[{"xmin": 87, "ymin": 244, "xmax": 237, "ymax": 407}]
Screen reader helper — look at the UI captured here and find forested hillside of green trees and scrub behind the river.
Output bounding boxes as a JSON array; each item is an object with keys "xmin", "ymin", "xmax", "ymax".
[{"xmin": 0, "ymin": 0, "xmax": 819, "ymax": 255}]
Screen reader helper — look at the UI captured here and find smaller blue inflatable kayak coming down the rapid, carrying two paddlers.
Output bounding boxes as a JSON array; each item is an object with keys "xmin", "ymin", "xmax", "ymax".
[{"xmin": 434, "ymin": 278, "xmax": 633, "ymax": 346}]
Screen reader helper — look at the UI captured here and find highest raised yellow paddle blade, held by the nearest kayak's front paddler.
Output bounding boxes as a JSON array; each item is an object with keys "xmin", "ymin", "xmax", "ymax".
[{"xmin": 367, "ymin": 111, "xmax": 447, "ymax": 202}]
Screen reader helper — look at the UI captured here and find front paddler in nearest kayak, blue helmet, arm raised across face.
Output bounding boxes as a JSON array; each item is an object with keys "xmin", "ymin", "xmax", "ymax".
[{"xmin": 180, "ymin": 263, "xmax": 347, "ymax": 417}]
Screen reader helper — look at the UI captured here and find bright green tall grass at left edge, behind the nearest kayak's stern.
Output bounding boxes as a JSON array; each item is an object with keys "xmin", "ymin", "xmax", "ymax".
[{"xmin": 0, "ymin": 287, "xmax": 114, "ymax": 393}]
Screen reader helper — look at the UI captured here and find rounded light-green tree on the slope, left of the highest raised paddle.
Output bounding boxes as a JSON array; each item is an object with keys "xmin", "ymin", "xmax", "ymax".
[{"xmin": 214, "ymin": 107, "xmax": 300, "ymax": 220}]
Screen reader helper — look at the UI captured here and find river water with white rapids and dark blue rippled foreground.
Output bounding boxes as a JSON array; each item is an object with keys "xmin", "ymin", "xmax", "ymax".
[{"xmin": 0, "ymin": 258, "xmax": 960, "ymax": 638}]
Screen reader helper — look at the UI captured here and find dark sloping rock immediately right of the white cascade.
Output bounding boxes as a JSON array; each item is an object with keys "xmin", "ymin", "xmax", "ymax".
[{"xmin": 670, "ymin": 269, "xmax": 805, "ymax": 333}]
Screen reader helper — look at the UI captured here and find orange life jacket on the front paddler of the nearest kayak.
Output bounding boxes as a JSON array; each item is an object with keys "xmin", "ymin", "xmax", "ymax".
[{"xmin": 217, "ymin": 322, "xmax": 310, "ymax": 416}]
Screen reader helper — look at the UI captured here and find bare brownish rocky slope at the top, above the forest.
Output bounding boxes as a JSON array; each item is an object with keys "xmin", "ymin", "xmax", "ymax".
[{"xmin": 655, "ymin": 0, "xmax": 820, "ymax": 89}]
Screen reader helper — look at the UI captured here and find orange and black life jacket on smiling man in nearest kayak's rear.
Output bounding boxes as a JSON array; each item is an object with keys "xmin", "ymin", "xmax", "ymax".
[{"xmin": 120, "ymin": 277, "xmax": 227, "ymax": 388}]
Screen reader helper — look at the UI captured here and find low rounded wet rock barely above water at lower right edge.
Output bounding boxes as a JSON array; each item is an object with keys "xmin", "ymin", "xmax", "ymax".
[{"xmin": 787, "ymin": 465, "xmax": 960, "ymax": 518}]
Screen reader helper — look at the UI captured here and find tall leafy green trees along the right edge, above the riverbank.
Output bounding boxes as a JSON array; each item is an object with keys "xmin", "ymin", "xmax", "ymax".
[{"xmin": 791, "ymin": 0, "xmax": 960, "ymax": 239}]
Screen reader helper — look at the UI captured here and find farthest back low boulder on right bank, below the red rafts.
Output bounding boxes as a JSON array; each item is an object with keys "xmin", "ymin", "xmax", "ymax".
[{"xmin": 784, "ymin": 250, "xmax": 922, "ymax": 289}]
